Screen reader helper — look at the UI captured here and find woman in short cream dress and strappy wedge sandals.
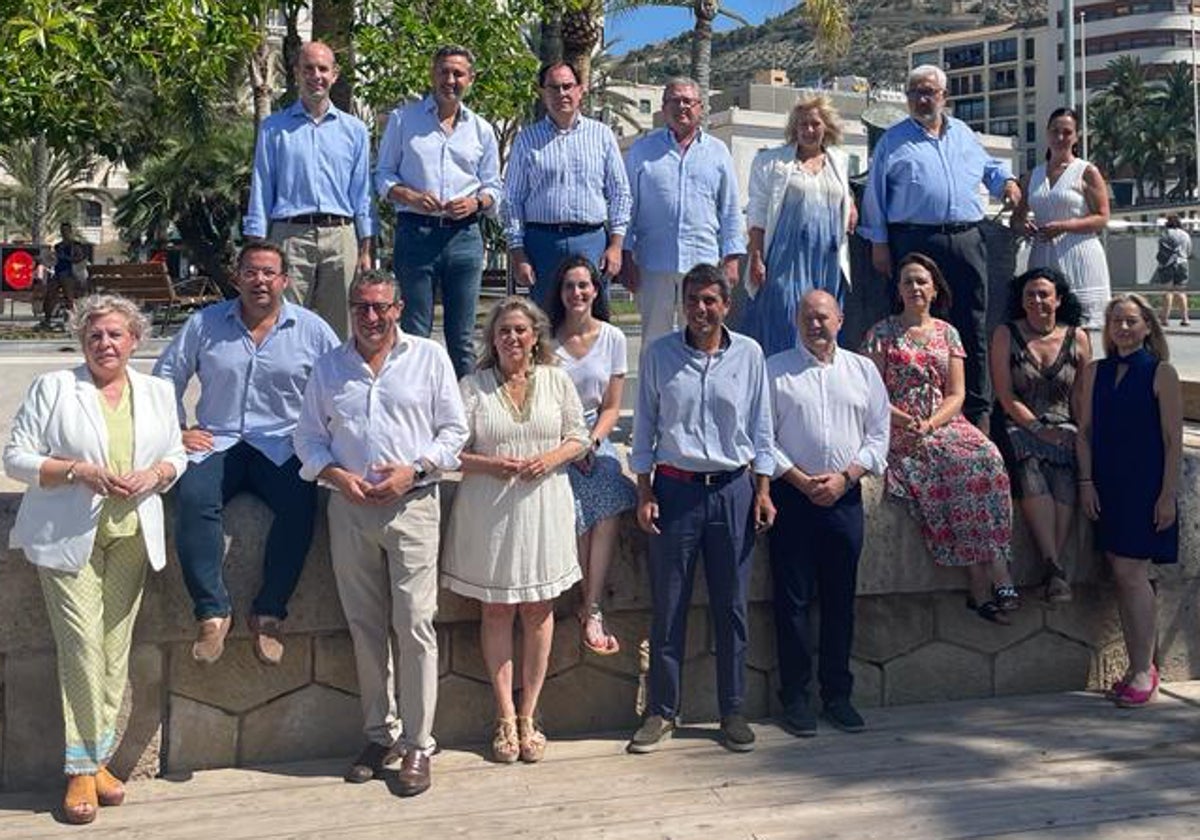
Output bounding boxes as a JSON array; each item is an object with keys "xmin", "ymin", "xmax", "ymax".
[{"xmin": 442, "ymin": 296, "xmax": 588, "ymax": 763}]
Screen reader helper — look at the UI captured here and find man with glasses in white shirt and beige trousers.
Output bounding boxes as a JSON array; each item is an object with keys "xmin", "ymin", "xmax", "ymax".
[{"xmin": 295, "ymin": 271, "xmax": 467, "ymax": 796}]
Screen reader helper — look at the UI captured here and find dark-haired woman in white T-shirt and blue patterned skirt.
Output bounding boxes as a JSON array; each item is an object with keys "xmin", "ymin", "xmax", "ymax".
[{"xmin": 546, "ymin": 257, "xmax": 637, "ymax": 656}]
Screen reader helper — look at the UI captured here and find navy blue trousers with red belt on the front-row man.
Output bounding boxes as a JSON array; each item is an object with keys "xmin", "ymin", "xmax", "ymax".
[{"xmin": 648, "ymin": 474, "xmax": 754, "ymax": 720}]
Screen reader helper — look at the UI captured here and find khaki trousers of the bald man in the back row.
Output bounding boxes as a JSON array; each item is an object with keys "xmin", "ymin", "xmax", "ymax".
[{"xmin": 269, "ymin": 222, "xmax": 359, "ymax": 341}]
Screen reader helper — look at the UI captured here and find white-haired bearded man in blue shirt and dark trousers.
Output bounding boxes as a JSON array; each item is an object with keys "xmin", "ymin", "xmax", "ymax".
[{"xmin": 858, "ymin": 65, "xmax": 1021, "ymax": 428}]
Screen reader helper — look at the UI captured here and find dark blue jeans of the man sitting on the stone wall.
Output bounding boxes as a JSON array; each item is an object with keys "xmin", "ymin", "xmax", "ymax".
[{"xmin": 175, "ymin": 440, "xmax": 317, "ymax": 620}]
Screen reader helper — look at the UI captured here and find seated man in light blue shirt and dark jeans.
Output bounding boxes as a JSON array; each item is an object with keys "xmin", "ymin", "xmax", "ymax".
[{"xmin": 154, "ymin": 240, "xmax": 337, "ymax": 665}]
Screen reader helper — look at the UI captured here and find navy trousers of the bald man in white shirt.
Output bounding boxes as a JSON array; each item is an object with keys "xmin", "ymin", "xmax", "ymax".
[{"xmin": 767, "ymin": 480, "xmax": 863, "ymax": 708}]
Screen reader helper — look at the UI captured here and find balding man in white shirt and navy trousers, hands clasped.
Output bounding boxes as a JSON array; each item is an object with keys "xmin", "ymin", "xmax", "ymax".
[{"xmin": 767, "ymin": 290, "xmax": 892, "ymax": 737}]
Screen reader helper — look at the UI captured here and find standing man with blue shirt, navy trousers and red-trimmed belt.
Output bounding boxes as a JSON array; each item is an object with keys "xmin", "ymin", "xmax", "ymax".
[{"xmin": 628, "ymin": 263, "xmax": 775, "ymax": 752}]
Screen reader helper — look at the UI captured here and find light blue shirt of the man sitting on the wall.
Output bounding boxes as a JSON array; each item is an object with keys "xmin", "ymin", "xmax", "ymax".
[{"xmin": 154, "ymin": 298, "xmax": 340, "ymax": 464}]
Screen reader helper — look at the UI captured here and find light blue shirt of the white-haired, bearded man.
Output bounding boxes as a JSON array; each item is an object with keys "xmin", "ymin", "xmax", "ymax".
[{"xmin": 858, "ymin": 115, "xmax": 1013, "ymax": 242}]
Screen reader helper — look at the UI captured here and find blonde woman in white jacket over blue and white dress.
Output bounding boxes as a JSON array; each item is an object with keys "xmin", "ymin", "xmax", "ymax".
[{"xmin": 740, "ymin": 94, "xmax": 858, "ymax": 355}]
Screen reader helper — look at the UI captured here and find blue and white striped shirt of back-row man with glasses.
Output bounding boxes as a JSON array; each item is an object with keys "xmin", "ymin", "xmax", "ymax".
[{"xmin": 503, "ymin": 116, "xmax": 631, "ymax": 248}]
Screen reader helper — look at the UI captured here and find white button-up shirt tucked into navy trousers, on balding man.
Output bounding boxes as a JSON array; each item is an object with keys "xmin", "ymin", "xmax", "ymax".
[{"xmin": 767, "ymin": 344, "xmax": 892, "ymax": 479}]
